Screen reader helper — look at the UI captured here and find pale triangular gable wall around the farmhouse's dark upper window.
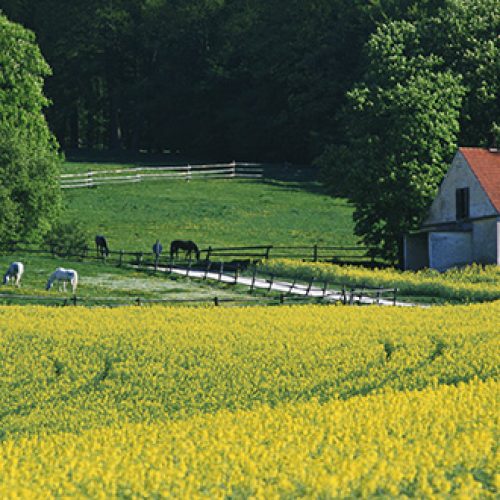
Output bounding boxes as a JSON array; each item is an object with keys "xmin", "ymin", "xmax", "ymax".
[{"xmin": 424, "ymin": 151, "xmax": 497, "ymax": 225}]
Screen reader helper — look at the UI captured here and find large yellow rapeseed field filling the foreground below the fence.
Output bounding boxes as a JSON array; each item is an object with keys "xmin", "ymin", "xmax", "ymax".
[{"xmin": 0, "ymin": 302, "xmax": 500, "ymax": 498}]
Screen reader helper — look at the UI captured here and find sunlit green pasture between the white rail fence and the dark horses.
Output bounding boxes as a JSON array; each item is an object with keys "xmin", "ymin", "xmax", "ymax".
[{"xmin": 59, "ymin": 163, "xmax": 357, "ymax": 252}]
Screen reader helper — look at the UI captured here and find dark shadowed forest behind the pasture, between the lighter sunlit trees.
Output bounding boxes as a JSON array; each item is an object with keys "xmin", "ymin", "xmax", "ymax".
[{"xmin": 0, "ymin": 0, "xmax": 442, "ymax": 161}]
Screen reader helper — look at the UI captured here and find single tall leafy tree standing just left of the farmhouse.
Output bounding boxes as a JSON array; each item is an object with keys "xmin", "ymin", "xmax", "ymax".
[{"xmin": 324, "ymin": 21, "xmax": 464, "ymax": 261}]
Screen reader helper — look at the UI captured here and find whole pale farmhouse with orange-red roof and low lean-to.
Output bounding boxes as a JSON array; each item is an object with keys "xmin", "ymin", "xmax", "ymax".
[{"xmin": 404, "ymin": 148, "xmax": 500, "ymax": 271}]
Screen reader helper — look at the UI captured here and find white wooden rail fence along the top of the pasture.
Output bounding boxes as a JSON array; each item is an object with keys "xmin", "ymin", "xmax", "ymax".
[{"xmin": 60, "ymin": 161, "xmax": 263, "ymax": 189}]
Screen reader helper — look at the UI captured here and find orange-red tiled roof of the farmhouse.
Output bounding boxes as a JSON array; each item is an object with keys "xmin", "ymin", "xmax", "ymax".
[{"xmin": 459, "ymin": 148, "xmax": 500, "ymax": 212}]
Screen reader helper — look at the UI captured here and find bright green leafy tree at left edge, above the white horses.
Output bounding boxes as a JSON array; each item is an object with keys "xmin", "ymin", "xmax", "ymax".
[{"xmin": 0, "ymin": 14, "xmax": 60, "ymax": 242}]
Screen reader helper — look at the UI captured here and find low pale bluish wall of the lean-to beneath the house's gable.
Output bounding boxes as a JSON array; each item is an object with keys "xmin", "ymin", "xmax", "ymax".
[{"xmin": 429, "ymin": 232, "xmax": 472, "ymax": 271}]
